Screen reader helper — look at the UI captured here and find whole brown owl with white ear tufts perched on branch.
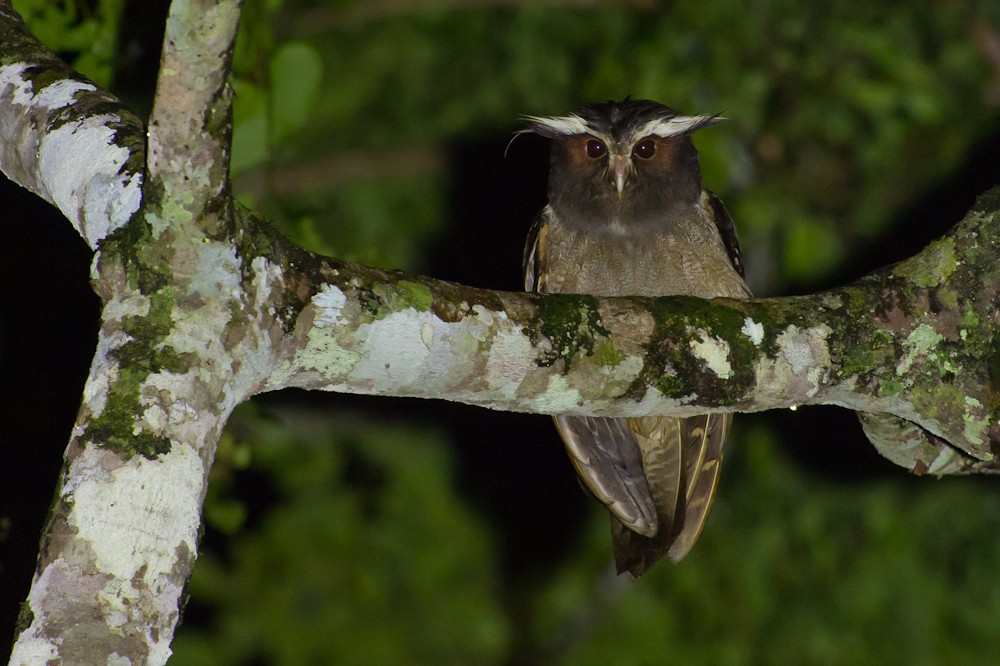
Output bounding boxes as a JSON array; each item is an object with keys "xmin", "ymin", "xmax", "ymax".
[{"xmin": 524, "ymin": 99, "xmax": 750, "ymax": 576}]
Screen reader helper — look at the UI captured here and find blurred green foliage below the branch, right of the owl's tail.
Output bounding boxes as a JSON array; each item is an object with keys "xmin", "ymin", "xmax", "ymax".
[{"xmin": 538, "ymin": 422, "xmax": 1000, "ymax": 664}]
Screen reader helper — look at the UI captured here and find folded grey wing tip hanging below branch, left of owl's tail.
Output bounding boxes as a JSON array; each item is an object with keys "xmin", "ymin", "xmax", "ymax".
[{"xmin": 553, "ymin": 416, "xmax": 660, "ymax": 536}]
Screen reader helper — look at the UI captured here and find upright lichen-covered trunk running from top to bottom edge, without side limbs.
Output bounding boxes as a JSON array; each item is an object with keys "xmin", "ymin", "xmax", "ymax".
[{"xmin": 9, "ymin": 0, "xmax": 250, "ymax": 664}]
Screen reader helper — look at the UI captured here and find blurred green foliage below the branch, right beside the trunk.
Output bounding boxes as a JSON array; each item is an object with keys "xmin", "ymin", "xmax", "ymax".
[{"xmin": 171, "ymin": 405, "xmax": 508, "ymax": 666}]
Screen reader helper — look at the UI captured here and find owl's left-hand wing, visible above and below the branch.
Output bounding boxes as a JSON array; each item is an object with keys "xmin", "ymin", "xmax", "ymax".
[{"xmin": 524, "ymin": 206, "xmax": 660, "ymax": 535}]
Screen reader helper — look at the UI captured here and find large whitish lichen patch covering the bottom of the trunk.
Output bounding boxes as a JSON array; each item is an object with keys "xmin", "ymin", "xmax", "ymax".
[{"xmin": 38, "ymin": 438, "xmax": 206, "ymax": 663}]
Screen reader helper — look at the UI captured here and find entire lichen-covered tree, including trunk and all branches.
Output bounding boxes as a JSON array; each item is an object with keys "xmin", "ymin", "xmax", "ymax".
[{"xmin": 0, "ymin": 0, "xmax": 1000, "ymax": 664}]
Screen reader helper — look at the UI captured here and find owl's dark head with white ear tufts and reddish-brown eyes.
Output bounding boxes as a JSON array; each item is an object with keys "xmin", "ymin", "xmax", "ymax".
[{"xmin": 527, "ymin": 100, "xmax": 719, "ymax": 229}]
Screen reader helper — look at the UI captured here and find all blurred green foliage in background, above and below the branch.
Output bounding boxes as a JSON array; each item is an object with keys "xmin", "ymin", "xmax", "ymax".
[{"xmin": 15, "ymin": 0, "xmax": 1000, "ymax": 665}]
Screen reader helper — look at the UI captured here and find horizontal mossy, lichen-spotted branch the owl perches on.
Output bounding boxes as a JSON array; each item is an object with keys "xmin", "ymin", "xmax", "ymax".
[{"xmin": 252, "ymin": 190, "xmax": 1000, "ymax": 472}]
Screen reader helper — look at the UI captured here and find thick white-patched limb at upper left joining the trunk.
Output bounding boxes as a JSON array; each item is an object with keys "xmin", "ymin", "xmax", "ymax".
[{"xmin": 0, "ymin": 0, "xmax": 145, "ymax": 248}]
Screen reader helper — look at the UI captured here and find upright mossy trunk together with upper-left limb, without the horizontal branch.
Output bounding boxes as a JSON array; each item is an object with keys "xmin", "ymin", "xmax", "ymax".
[{"xmin": 6, "ymin": 0, "xmax": 246, "ymax": 664}]
